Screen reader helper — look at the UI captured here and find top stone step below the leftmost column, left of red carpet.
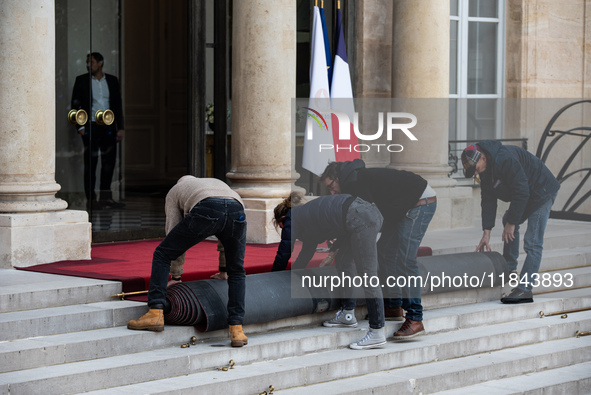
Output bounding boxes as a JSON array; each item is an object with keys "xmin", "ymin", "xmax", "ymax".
[{"xmin": 0, "ymin": 269, "xmax": 121, "ymax": 313}]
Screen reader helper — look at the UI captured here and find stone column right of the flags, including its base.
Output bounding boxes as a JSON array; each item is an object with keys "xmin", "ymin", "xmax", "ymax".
[{"xmin": 390, "ymin": 0, "xmax": 473, "ymax": 229}]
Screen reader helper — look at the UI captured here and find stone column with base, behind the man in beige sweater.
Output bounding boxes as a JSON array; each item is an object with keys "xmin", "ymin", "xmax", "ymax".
[{"xmin": 228, "ymin": 0, "xmax": 296, "ymax": 243}]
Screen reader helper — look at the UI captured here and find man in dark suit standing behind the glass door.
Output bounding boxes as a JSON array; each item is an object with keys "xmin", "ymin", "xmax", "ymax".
[{"xmin": 72, "ymin": 52, "xmax": 125, "ymax": 209}]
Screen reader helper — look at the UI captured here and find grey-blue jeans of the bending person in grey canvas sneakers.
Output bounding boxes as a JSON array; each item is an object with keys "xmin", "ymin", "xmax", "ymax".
[{"xmin": 336, "ymin": 198, "xmax": 386, "ymax": 329}]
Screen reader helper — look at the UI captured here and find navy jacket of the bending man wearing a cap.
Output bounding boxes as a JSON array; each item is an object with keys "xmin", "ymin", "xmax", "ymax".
[{"xmin": 477, "ymin": 140, "xmax": 560, "ymax": 229}]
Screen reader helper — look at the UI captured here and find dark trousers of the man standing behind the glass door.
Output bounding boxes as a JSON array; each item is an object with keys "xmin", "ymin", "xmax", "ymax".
[{"xmin": 82, "ymin": 122, "xmax": 117, "ymax": 201}]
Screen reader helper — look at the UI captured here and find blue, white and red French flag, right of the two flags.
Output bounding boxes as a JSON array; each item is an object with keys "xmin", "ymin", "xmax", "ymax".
[{"xmin": 330, "ymin": 8, "xmax": 360, "ymax": 162}]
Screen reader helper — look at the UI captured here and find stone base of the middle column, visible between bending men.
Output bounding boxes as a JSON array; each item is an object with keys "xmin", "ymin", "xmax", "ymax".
[{"xmin": 242, "ymin": 198, "xmax": 283, "ymax": 244}]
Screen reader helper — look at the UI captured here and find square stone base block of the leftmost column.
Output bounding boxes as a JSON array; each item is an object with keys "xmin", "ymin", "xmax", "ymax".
[{"xmin": 0, "ymin": 210, "xmax": 92, "ymax": 269}]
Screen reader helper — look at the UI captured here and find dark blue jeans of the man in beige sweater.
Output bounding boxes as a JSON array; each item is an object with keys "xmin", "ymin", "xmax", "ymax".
[{"xmin": 148, "ymin": 198, "xmax": 246, "ymax": 325}]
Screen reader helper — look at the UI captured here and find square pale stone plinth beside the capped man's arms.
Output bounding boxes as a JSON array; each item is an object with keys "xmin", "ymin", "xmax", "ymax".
[{"xmin": 427, "ymin": 187, "xmax": 474, "ymax": 232}]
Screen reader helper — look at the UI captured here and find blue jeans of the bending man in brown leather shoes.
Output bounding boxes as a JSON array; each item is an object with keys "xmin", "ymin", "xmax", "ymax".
[{"xmin": 378, "ymin": 202, "xmax": 437, "ymax": 321}]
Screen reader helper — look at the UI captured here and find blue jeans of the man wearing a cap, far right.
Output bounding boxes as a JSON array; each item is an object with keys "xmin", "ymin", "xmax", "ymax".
[{"xmin": 503, "ymin": 193, "xmax": 557, "ymax": 291}]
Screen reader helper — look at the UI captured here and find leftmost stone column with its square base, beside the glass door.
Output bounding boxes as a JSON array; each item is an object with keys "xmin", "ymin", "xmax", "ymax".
[{"xmin": 0, "ymin": 0, "xmax": 90, "ymax": 268}]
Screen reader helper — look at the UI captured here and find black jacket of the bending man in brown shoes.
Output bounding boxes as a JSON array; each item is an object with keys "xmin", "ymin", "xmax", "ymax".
[{"xmin": 337, "ymin": 159, "xmax": 427, "ymax": 223}]
